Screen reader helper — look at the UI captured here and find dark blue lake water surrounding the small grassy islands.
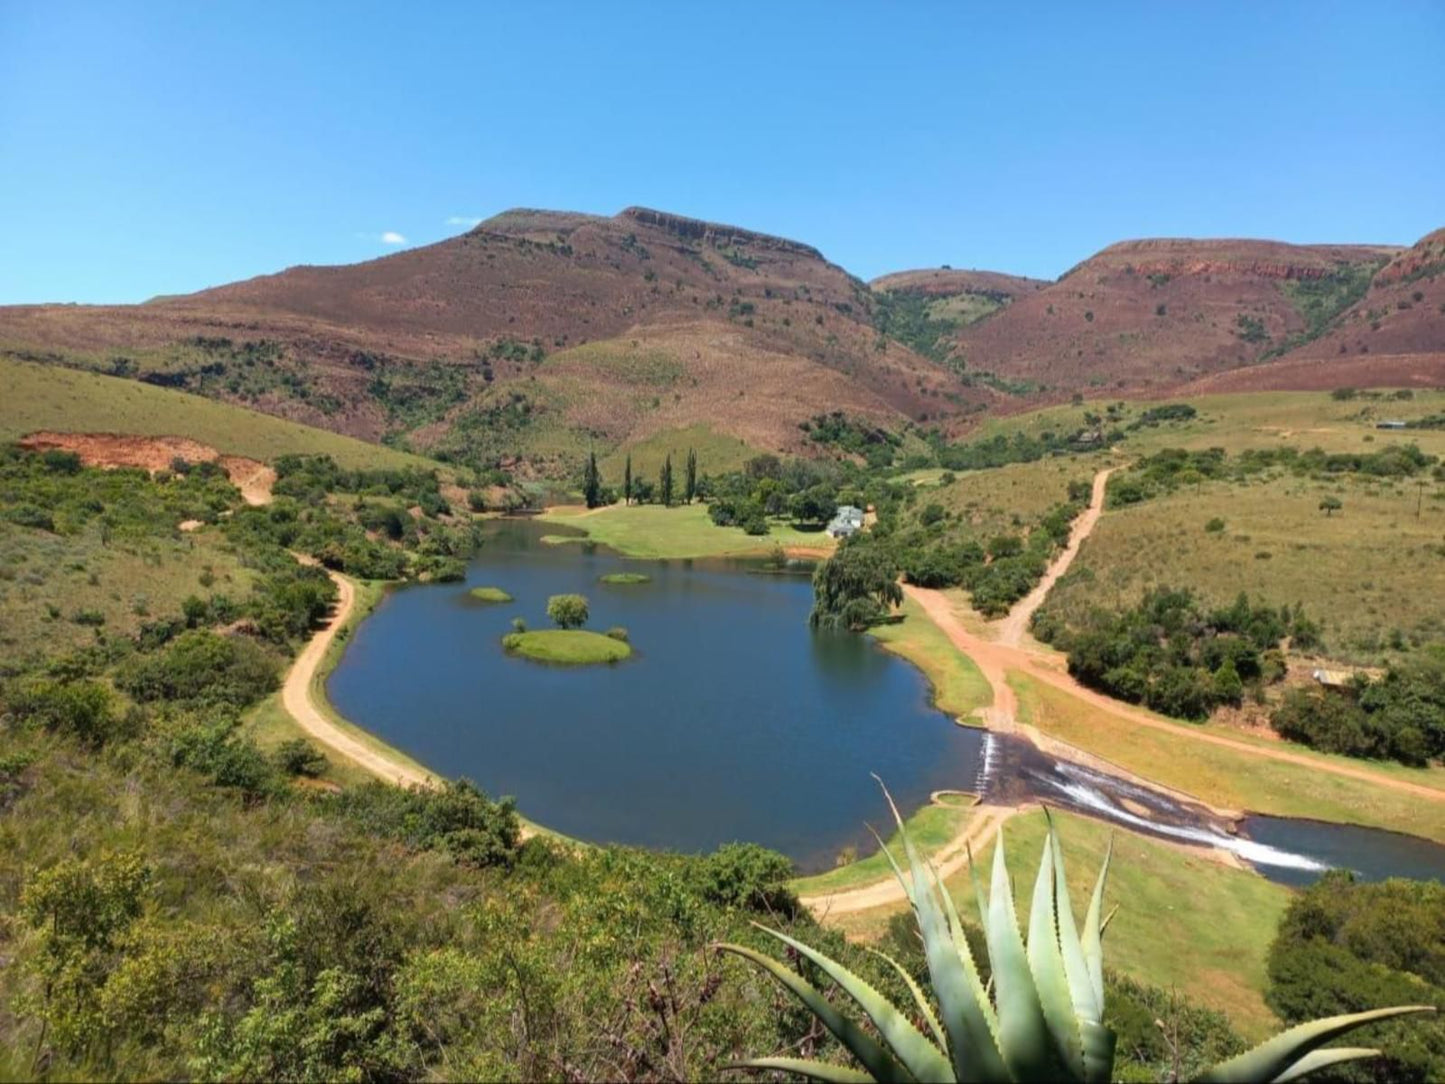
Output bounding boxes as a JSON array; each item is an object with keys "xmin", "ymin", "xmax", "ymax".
[{"xmin": 328, "ymin": 520, "xmax": 983, "ymax": 869}]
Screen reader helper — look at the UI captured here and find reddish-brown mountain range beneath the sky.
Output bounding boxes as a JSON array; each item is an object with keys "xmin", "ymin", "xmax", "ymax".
[{"xmin": 0, "ymin": 207, "xmax": 1445, "ymax": 473}]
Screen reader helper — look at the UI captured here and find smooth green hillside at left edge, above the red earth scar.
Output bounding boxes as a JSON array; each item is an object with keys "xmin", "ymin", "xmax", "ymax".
[{"xmin": 0, "ymin": 358, "xmax": 436, "ymax": 468}]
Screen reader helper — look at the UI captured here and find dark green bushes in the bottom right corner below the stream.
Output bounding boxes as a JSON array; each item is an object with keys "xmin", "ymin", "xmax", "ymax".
[{"xmin": 1266, "ymin": 870, "xmax": 1445, "ymax": 1084}]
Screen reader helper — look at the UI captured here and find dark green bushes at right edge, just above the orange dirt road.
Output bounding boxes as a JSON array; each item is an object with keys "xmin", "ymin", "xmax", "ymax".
[{"xmin": 1270, "ymin": 645, "xmax": 1445, "ymax": 765}]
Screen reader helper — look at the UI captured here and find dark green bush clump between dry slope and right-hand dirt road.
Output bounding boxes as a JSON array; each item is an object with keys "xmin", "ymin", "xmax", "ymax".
[{"xmin": 1033, "ymin": 588, "xmax": 1319, "ymax": 718}]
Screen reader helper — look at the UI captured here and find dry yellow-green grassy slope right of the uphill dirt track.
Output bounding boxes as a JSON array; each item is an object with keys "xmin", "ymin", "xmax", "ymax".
[{"xmin": 1048, "ymin": 476, "xmax": 1445, "ymax": 663}]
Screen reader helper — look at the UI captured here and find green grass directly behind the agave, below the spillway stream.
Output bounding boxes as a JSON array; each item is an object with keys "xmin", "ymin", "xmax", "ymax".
[{"xmin": 840, "ymin": 814, "xmax": 1290, "ymax": 1038}]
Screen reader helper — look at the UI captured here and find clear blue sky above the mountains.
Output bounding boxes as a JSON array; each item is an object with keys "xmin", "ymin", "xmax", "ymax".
[{"xmin": 0, "ymin": 0, "xmax": 1445, "ymax": 304}]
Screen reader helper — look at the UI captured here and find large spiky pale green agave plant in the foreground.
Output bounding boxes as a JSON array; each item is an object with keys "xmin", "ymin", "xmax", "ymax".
[{"xmin": 720, "ymin": 788, "xmax": 1433, "ymax": 1084}]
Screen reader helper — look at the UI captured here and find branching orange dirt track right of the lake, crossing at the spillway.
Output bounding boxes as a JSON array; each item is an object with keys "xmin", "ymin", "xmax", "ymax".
[{"xmin": 802, "ymin": 467, "xmax": 1445, "ymax": 916}]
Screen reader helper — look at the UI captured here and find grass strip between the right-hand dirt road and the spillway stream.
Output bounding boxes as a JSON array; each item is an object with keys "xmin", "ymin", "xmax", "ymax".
[{"xmin": 1009, "ymin": 674, "xmax": 1445, "ymax": 843}]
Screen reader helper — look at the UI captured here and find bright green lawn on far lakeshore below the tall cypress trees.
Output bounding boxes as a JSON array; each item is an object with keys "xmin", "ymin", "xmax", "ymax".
[{"xmin": 539, "ymin": 503, "xmax": 834, "ymax": 558}]
